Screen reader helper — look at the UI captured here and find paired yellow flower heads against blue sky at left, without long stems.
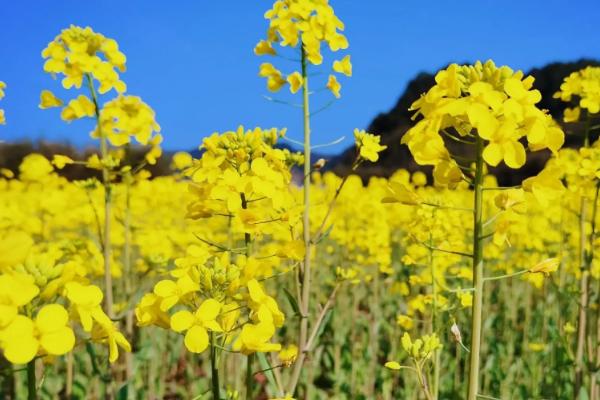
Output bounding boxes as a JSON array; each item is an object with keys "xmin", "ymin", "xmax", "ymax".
[{"xmin": 39, "ymin": 26, "xmax": 162, "ymax": 170}]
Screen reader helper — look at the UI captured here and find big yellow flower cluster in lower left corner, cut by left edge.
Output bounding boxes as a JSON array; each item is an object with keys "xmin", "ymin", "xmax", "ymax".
[{"xmin": 0, "ymin": 258, "xmax": 131, "ymax": 364}]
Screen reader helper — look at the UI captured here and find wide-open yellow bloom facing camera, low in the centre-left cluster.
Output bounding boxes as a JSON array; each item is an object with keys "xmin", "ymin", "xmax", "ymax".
[{"xmin": 171, "ymin": 299, "xmax": 223, "ymax": 353}]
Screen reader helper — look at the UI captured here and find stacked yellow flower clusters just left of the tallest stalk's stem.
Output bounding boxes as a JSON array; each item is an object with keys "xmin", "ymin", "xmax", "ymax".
[{"xmin": 136, "ymin": 127, "xmax": 304, "ymax": 354}]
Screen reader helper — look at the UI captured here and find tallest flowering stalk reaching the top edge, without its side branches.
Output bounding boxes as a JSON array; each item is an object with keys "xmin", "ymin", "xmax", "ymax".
[{"xmin": 254, "ymin": 0, "xmax": 352, "ymax": 393}]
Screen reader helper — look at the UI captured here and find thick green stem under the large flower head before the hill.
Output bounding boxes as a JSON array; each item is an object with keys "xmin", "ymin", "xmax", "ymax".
[{"xmin": 467, "ymin": 135, "xmax": 483, "ymax": 400}]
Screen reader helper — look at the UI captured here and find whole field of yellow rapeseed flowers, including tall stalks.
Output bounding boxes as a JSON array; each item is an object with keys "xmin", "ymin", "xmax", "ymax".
[{"xmin": 0, "ymin": 0, "xmax": 600, "ymax": 400}]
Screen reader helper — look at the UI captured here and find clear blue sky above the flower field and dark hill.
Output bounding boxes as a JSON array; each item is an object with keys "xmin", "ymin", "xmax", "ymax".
[{"xmin": 0, "ymin": 0, "xmax": 600, "ymax": 153}]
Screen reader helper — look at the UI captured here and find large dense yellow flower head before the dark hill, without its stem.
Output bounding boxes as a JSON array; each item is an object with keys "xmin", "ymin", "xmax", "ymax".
[{"xmin": 402, "ymin": 61, "xmax": 564, "ymax": 188}]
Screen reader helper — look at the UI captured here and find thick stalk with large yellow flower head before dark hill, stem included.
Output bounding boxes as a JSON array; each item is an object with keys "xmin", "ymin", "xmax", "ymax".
[{"xmin": 402, "ymin": 61, "xmax": 564, "ymax": 400}]
